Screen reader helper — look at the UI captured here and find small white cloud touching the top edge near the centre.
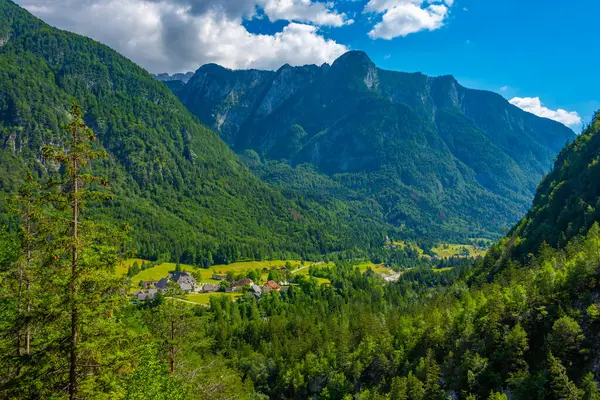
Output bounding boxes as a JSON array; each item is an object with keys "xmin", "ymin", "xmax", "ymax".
[{"xmin": 258, "ymin": 0, "xmax": 354, "ymax": 26}]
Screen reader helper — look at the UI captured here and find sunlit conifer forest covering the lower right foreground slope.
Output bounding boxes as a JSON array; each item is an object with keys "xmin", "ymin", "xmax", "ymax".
[{"xmin": 188, "ymin": 114, "xmax": 600, "ymax": 400}]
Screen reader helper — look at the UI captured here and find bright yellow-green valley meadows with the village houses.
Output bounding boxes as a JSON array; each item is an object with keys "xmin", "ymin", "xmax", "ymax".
[{"xmin": 129, "ymin": 250, "xmax": 480, "ymax": 305}]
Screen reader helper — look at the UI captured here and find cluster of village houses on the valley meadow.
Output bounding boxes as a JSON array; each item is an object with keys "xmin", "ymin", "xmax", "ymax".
[{"xmin": 134, "ymin": 271, "xmax": 288, "ymax": 301}]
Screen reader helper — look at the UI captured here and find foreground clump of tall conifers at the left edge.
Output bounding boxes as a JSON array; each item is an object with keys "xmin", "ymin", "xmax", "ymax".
[{"xmin": 0, "ymin": 105, "xmax": 131, "ymax": 399}]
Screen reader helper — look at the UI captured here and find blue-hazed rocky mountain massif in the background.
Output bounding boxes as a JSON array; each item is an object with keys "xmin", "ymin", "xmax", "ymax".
[{"xmin": 171, "ymin": 51, "xmax": 575, "ymax": 238}]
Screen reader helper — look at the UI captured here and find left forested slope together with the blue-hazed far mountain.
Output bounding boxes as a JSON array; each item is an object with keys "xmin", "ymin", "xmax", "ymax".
[{"xmin": 0, "ymin": 0, "xmax": 574, "ymax": 264}]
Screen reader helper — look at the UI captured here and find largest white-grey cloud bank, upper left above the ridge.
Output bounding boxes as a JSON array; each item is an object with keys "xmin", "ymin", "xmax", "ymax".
[{"xmin": 18, "ymin": 0, "xmax": 348, "ymax": 72}]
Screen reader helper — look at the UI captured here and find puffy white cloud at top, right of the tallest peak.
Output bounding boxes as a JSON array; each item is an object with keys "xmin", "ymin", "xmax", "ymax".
[{"xmin": 364, "ymin": 0, "xmax": 454, "ymax": 39}]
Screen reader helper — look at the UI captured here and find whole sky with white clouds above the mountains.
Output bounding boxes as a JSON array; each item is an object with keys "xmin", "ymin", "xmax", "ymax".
[{"xmin": 17, "ymin": 0, "xmax": 600, "ymax": 128}]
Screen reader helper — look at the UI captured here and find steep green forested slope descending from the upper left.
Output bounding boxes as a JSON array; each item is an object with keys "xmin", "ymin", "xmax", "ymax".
[{"xmin": 0, "ymin": 0, "xmax": 384, "ymax": 264}]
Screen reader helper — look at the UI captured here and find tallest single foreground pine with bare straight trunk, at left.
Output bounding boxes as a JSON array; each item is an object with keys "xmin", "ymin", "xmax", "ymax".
[{"xmin": 43, "ymin": 104, "xmax": 129, "ymax": 399}]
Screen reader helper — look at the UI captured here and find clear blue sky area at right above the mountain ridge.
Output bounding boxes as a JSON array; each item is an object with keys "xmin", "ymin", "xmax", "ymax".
[{"xmin": 352, "ymin": 0, "xmax": 600, "ymax": 128}]
